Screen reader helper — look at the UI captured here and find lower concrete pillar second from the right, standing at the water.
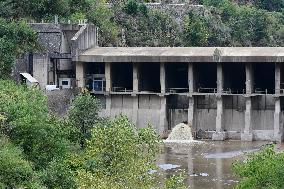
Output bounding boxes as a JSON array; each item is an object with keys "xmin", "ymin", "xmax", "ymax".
[{"xmin": 241, "ymin": 97, "xmax": 253, "ymax": 141}]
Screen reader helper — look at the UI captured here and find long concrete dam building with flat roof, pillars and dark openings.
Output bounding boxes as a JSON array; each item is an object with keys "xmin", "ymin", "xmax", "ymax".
[{"xmin": 73, "ymin": 47, "xmax": 284, "ymax": 141}]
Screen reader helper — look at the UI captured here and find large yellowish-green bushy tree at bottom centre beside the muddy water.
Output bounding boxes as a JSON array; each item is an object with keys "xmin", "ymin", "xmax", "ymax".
[{"xmin": 72, "ymin": 116, "xmax": 184, "ymax": 189}]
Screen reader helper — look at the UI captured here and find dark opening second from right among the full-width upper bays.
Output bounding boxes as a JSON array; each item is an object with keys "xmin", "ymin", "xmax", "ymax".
[{"xmin": 223, "ymin": 63, "xmax": 246, "ymax": 94}]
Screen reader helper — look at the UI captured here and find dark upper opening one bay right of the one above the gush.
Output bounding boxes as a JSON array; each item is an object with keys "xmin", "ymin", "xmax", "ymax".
[{"xmin": 194, "ymin": 63, "xmax": 217, "ymax": 93}]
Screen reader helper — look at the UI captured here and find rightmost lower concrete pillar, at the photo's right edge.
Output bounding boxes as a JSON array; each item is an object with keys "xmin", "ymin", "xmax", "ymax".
[{"xmin": 274, "ymin": 97, "xmax": 283, "ymax": 142}]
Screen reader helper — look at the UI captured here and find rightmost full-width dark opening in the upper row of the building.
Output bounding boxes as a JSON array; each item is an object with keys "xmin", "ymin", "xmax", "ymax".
[{"xmin": 253, "ymin": 63, "xmax": 275, "ymax": 94}]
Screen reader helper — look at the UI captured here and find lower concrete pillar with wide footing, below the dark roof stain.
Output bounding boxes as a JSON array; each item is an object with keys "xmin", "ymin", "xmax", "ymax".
[{"xmin": 212, "ymin": 96, "xmax": 227, "ymax": 141}]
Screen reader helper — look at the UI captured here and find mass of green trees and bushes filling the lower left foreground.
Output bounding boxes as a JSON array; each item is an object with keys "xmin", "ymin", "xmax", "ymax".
[{"xmin": 0, "ymin": 80, "xmax": 184, "ymax": 189}]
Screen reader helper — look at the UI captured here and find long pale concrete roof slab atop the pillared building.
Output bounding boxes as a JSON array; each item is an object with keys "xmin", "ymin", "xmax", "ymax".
[{"xmin": 75, "ymin": 47, "xmax": 284, "ymax": 63}]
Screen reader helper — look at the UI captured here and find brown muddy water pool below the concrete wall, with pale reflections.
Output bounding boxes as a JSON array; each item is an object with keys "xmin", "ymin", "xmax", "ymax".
[{"xmin": 158, "ymin": 141, "xmax": 267, "ymax": 189}]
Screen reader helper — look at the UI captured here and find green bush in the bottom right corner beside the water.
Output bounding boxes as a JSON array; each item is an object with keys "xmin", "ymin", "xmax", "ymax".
[{"xmin": 234, "ymin": 145, "xmax": 284, "ymax": 189}]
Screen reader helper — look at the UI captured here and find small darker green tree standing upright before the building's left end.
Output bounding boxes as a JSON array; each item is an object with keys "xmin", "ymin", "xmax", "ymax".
[{"xmin": 68, "ymin": 93, "xmax": 100, "ymax": 147}]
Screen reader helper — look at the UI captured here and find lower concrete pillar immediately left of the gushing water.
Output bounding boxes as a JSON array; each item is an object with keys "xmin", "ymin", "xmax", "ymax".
[{"xmin": 157, "ymin": 96, "xmax": 168, "ymax": 136}]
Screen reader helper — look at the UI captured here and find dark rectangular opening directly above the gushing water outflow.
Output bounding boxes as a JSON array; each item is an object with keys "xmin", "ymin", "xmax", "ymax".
[{"xmin": 165, "ymin": 63, "xmax": 188, "ymax": 93}]
